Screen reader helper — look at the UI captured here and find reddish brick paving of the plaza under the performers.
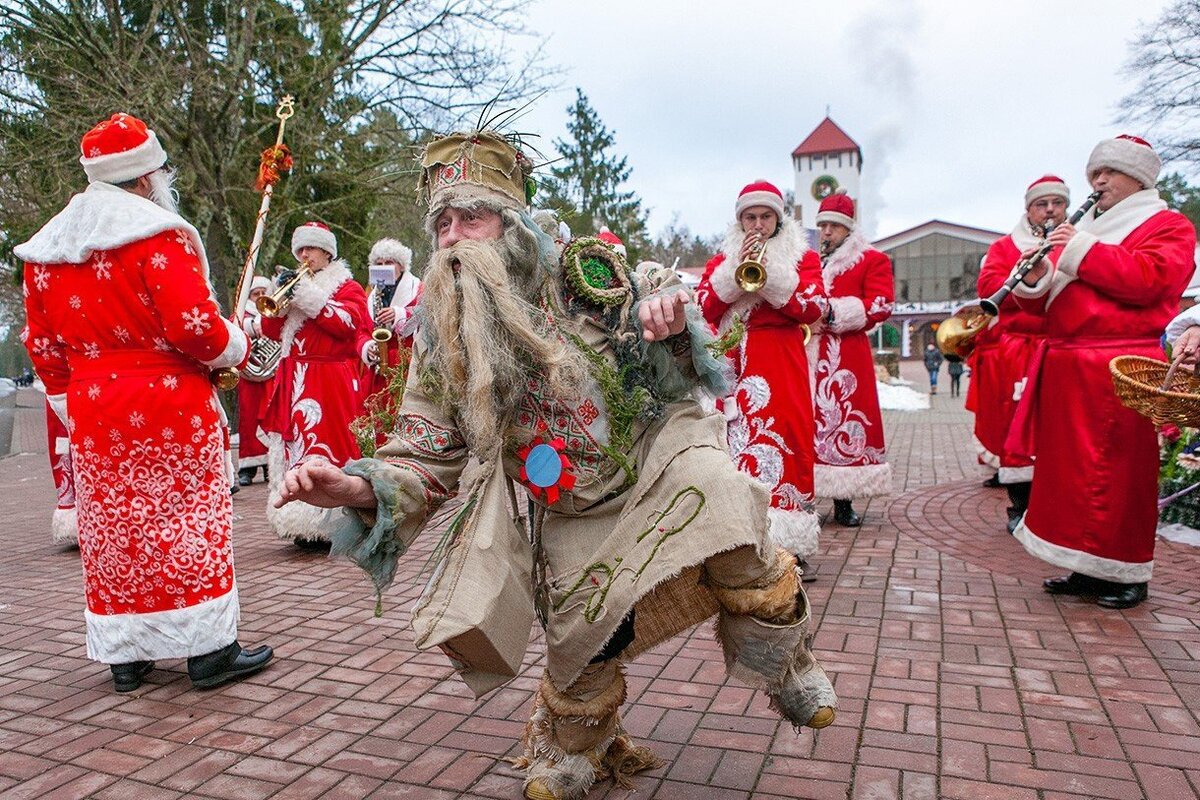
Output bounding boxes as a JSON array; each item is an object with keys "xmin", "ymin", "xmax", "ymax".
[{"xmin": 0, "ymin": 365, "xmax": 1200, "ymax": 800}]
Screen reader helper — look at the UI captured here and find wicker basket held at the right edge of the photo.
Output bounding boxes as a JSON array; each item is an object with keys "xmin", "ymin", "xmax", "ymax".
[{"xmin": 1109, "ymin": 355, "xmax": 1200, "ymax": 428}]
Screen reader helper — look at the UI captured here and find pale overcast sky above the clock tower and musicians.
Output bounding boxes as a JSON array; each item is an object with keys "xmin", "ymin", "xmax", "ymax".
[{"xmin": 517, "ymin": 0, "xmax": 1168, "ymax": 244}]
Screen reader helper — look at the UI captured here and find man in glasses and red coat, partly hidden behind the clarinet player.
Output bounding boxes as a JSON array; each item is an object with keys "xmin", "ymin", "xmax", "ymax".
[{"xmin": 971, "ymin": 175, "xmax": 1070, "ymax": 534}]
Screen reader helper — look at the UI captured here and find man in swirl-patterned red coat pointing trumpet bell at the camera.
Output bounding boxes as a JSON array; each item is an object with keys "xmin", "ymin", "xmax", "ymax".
[{"xmin": 696, "ymin": 181, "xmax": 828, "ymax": 559}]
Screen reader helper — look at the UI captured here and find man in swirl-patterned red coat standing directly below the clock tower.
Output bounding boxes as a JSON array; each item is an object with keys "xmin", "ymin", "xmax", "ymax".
[{"xmin": 808, "ymin": 193, "xmax": 895, "ymax": 528}]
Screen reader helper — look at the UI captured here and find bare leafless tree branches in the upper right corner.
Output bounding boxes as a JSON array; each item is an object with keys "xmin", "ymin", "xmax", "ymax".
[{"xmin": 1120, "ymin": 0, "xmax": 1200, "ymax": 166}]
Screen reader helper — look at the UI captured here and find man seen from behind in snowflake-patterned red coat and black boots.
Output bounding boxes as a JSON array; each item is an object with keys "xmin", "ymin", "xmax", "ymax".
[{"xmin": 13, "ymin": 114, "xmax": 271, "ymax": 692}]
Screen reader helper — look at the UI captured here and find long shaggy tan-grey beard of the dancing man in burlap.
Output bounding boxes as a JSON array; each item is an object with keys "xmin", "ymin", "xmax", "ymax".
[{"xmin": 421, "ymin": 230, "xmax": 586, "ymax": 458}]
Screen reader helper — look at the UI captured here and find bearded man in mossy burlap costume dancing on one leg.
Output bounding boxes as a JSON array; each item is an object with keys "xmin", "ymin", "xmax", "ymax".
[{"xmin": 274, "ymin": 131, "xmax": 835, "ymax": 800}]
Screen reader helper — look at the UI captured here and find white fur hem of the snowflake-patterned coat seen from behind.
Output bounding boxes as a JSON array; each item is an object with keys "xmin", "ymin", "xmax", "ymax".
[{"xmin": 84, "ymin": 584, "xmax": 238, "ymax": 664}]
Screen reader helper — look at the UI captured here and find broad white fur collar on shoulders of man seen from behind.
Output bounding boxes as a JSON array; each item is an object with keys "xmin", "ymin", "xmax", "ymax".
[{"xmin": 13, "ymin": 184, "xmax": 209, "ymax": 279}]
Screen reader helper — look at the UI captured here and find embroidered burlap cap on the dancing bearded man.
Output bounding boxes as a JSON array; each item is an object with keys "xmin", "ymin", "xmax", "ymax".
[{"xmin": 416, "ymin": 131, "xmax": 534, "ymax": 217}]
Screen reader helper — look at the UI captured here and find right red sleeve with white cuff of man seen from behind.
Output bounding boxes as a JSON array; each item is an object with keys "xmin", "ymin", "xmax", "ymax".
[{"xmin": 140, "ymin": 230, "xmax": 250, "ymax": 367}]
